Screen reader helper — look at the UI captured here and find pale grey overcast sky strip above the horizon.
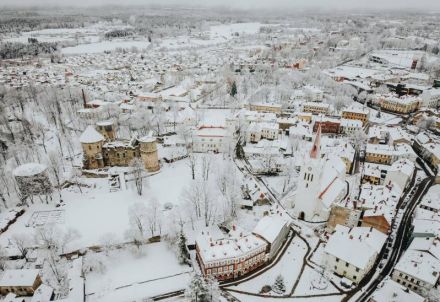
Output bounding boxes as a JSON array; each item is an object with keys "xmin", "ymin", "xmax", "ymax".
[{"xmin": 0, "ymin": 0, "xmax": 440, "ymax": 12}]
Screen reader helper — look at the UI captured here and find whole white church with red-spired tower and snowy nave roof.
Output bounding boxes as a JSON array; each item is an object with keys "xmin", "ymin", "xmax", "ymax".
[{"xmin": 292, "ymin": 126, "xmax": 348, "ymax": 222}]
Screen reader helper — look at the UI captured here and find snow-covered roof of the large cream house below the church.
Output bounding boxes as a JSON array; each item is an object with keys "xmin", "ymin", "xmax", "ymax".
[{"xmin": 325, "ymin": 225, "xmax": 387, "ymax": 269}]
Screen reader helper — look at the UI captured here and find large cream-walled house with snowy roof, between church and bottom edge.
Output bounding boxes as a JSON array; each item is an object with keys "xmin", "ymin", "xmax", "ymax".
[{"xmin": 324, "ymin": 225, "xmax": 386, "ymax": 283}]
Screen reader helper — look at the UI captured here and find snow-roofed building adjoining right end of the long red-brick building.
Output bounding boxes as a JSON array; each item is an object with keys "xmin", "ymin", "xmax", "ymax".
[{"xmin": 252, "ymin": 213, "xmax": 289, "ymax": 259}]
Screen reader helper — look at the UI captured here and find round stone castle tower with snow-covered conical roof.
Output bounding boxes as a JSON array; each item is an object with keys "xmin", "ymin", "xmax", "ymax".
[{"xmin": 79, "ymin": 126, "xmax": 105, "ymax": 169}]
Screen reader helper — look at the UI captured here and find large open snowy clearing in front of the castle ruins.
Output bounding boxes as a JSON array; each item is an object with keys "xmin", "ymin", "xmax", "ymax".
[{"xmin": 0, "ymin": 154, "xmax": 239, "ymax": 252}]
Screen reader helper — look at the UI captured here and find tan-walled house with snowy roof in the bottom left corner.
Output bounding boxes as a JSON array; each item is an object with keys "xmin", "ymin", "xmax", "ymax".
[{"xmin": 0, "ymin": 269, "xmax": 42, "ymax": 296}]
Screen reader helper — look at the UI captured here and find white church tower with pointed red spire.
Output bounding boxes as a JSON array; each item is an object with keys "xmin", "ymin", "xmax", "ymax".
[{"xmin": 293, "ymin": 125, "xmax": 325, "ymax": 221}]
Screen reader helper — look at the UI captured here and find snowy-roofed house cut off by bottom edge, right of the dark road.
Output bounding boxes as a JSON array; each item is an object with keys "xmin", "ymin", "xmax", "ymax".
[{"xmin": 368, "ymin": 279, "xmax": 426, "ymax": 302}]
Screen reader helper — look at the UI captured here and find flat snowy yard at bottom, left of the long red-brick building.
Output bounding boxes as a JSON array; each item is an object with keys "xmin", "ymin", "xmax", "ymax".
[{"xmin": 86, "ymin": 242, "xmax": 192, "ymax": 301}]
